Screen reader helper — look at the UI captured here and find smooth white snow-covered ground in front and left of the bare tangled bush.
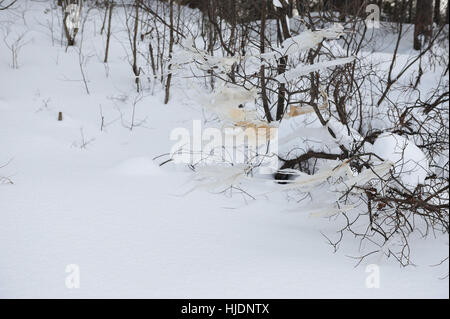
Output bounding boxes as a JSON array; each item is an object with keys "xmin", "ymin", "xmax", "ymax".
[{"xmin": 0, "ymin": 1, "xmax": 449, "ymax": 298}]
